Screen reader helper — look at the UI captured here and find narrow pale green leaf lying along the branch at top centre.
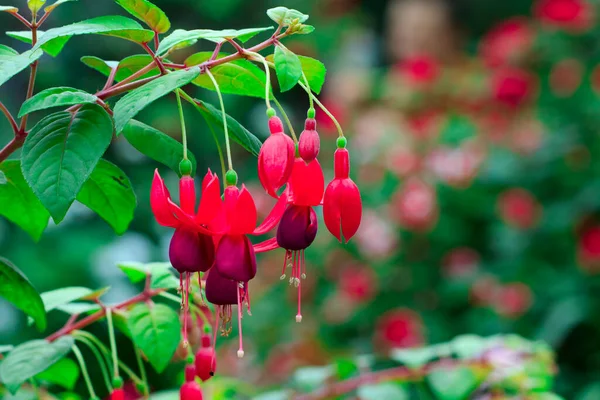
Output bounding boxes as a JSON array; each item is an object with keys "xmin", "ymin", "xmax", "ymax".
[{"xmin": 156, "ymin": 26, "xmax": 273, "ymax": 55}]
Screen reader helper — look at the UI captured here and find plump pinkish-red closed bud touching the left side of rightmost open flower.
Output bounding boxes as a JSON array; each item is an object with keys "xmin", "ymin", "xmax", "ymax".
[{"xmin": 258, "ymin": 116, "xmax": 295, "ymax": 198}]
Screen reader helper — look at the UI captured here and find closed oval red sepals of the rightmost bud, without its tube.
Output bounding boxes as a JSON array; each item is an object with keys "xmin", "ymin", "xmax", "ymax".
[{"xmin": 323, "ymin": 178, "xmax": 362, "ymax": 242}]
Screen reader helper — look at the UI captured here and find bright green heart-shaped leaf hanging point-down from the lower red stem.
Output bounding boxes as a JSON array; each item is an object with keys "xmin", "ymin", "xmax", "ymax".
[{"xmin": 128, "ymin": 304, "xmax": 181, "ymax": 372}]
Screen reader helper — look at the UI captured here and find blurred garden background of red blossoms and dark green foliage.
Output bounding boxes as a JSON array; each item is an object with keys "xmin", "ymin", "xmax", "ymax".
[{"xmin": 0, "ymin": 0, "xmax": 600, "ymax": 399}]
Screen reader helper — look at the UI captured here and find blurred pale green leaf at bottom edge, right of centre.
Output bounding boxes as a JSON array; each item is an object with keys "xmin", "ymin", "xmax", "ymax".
[{"xmin": 427, "ymin": 366, "xmax": 479, "ymax": 400}]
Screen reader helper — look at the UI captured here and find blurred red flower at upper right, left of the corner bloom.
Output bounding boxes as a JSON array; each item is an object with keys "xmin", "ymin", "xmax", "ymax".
[{"xmin": 479, "ymin": 17, "xmax": 534, "ymax": 67}]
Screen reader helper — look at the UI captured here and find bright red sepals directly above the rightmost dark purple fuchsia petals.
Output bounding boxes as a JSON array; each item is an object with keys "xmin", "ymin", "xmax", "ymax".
[{"xmin": 290, "ymin": 158, "xmax": 325, "ymax": 206}]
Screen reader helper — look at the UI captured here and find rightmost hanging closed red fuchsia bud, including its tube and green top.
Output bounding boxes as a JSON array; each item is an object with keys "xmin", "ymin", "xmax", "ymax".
[{"xmin": 323, "ymin": 137, "xmax": 362, "ymax": 243}]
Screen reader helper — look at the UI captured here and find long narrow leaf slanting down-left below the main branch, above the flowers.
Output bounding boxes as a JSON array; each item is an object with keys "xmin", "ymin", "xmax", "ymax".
[{"xmin": 114, "ymin": 67, "xmax": 200, "ymax": 134}]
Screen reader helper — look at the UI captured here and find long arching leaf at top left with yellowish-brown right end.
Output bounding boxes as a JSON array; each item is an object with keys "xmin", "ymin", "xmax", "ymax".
[{"xmin": 33, "ymin": 15, "xmax": 154, "ymax": 49}]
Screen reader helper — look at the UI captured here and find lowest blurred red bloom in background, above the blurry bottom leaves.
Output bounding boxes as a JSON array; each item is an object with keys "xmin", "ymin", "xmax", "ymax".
[{"xmin": 377, "ymin": 308, "xmax": 424, "ymax": 348}]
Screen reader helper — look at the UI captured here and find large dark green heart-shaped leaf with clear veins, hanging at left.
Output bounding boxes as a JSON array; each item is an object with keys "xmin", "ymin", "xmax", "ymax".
[{"xmin": 21, "ymin": 104, "xmax": 113, "ymax": 223}]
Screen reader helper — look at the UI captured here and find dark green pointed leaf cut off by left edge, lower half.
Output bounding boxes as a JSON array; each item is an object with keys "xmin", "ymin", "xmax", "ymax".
[{"xmin": 0, "ymin": 257, "xmax": 46, "ymax": 331}]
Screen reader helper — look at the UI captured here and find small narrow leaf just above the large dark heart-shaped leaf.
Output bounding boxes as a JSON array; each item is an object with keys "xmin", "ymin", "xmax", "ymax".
[{"xmin": 19, "ymin": 87, "xmax": 98, "ymax": 118}]
